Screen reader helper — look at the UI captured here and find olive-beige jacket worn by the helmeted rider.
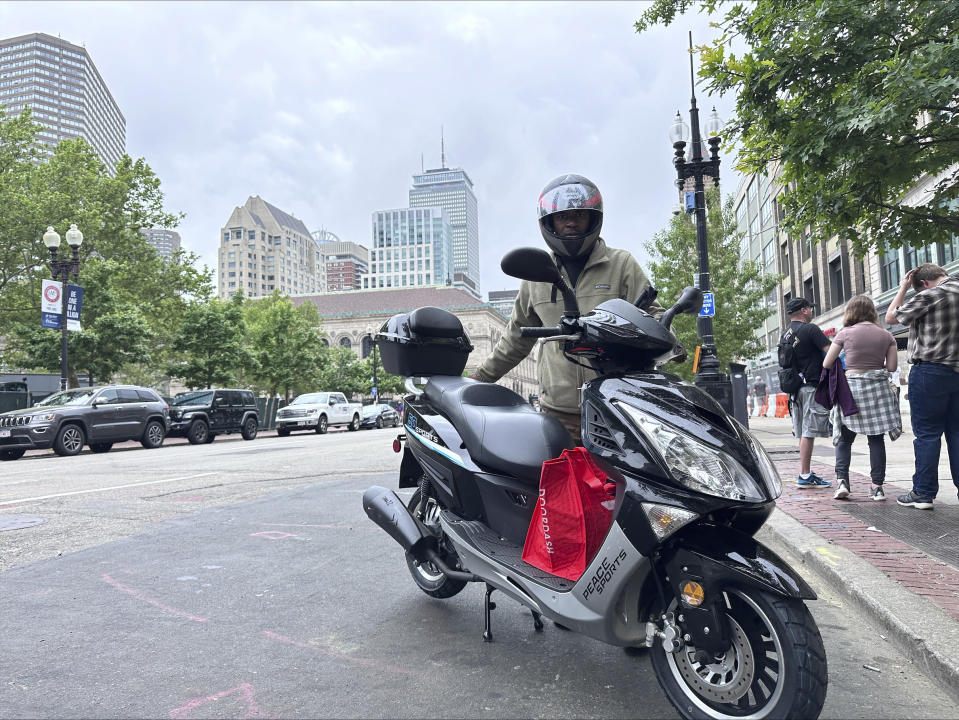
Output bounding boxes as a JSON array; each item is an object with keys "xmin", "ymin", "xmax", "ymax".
[{"xmin": 475, "ymin": 238, "xmax": 664, "ymax": 414}]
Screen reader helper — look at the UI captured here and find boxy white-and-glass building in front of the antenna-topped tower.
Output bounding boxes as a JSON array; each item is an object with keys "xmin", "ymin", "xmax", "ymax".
[{"xmin": 363, "ymin": 207, "xmax": 453, "ymax": 290}]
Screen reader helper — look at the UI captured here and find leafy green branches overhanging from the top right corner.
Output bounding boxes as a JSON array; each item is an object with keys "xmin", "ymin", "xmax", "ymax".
[{"xmin": 636, "ymin": 0, "xmax": 959, "ymax": 255}]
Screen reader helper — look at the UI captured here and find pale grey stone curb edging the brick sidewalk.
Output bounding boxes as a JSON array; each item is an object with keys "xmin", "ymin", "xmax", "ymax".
[{"xmin": 758, "ymin": 508, "xmax": 959, "ymax": 702}]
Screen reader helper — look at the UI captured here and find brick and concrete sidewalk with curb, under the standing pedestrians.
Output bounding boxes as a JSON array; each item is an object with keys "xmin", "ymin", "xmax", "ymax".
[{"xmin": 749, "ymin": 410, "xmax": 959, "ymax": 701}]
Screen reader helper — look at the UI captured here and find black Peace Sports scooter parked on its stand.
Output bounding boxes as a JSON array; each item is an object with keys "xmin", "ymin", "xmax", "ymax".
[{"xmin": 363, "ymin": 248, "xmax": 827, "ymax": 718}]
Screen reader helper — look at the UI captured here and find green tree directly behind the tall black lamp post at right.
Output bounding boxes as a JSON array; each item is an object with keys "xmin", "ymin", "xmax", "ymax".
[{"xmin": 645, "ymin": 189, "xmax": 782, "ymax": 379}]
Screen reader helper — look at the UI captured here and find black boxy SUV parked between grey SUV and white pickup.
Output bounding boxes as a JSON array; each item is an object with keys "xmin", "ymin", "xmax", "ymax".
[{"xmin": 170, "ymin": 390, "xmax": 260, "ymax": 445}]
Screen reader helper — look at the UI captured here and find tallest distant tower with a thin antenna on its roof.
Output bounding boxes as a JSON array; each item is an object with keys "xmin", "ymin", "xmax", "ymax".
[{"xmin": 410, "ymin": 139, "xmax": 480, "ymax": 298}]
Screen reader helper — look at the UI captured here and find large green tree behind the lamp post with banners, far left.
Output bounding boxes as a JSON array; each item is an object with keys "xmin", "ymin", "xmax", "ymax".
[{"xmin": 0, "ymin": 111, "xmax": 213, "ymax": 384}]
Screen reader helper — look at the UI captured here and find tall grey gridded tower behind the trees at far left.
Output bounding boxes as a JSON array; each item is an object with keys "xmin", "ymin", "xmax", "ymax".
[{"xmin": 0, "ymin": 33, "xmax": 126, "ymax": 171}]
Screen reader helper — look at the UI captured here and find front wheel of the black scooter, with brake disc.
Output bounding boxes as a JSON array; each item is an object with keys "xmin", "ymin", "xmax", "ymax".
[{"xmin": 651, "ymin": 588, "xmax": 828, "ymax": 720}]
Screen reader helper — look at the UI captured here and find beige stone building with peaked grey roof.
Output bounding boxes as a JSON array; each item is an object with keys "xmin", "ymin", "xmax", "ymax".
[{"xmin": 217, "ymin": 195, "xmax": 326, "ymax": 300}]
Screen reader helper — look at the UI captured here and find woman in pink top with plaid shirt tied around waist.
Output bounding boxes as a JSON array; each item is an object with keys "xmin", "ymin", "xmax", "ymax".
[{"xmin": 823, "ymin": 295, "xmax": 902, "ymax": 500}]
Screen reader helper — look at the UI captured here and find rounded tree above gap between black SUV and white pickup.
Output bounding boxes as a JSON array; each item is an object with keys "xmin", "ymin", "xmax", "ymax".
[{"xmin": 244, "ymin": 290, "xmax": 323, "ymax": 401}]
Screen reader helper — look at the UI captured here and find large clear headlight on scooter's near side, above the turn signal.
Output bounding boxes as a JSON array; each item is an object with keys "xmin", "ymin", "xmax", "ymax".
[{"xmin": 616, "ymin": 403, "xmax": 765, "ymax": 502}]
